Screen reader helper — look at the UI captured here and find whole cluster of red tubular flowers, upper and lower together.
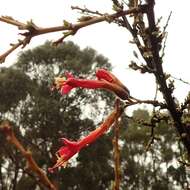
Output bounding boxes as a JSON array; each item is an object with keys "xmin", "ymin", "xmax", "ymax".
[{"xmin": 49, "ymin": 69, "xmax": 125, "ymax": 172}]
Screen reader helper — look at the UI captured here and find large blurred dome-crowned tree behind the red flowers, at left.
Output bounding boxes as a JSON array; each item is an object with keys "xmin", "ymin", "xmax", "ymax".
[{"xmin": 0, "ymin": 42, "xmax": 113, "ymax": 190}]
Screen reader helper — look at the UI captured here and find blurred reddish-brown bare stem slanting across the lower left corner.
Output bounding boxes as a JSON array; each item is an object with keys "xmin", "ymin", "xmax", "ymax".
[{"xmin": 0, "ymin": 122, "xmax": 56, "ymax": 190}]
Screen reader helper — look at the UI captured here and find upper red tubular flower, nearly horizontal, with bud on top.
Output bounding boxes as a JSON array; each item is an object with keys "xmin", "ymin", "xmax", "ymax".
[{"xmin": 55, "ymin": 69, "xmax": 130, "ymax": 100}]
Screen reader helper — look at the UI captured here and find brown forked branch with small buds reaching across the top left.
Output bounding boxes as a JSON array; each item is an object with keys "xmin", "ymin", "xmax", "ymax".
[{"xmin": 0, "ymin": 6, "xmax": 145, "ymax": 63}]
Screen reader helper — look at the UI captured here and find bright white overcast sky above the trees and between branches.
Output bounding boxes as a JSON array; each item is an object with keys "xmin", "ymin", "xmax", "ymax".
[{"xmin": 0, "ymin": 0, "xmax": 190, "ymax": 110}]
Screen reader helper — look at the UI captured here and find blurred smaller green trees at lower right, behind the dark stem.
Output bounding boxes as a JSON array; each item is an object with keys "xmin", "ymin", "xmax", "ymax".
[{"xmin": 121, "ymin": 109, "xmax": 190, "ymax": 190}]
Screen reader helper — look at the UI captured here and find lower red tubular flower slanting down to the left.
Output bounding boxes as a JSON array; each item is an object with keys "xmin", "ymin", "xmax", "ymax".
[{"xmin": 48, "ymin": 106, "xmax": 121, "ymax": 172}]
